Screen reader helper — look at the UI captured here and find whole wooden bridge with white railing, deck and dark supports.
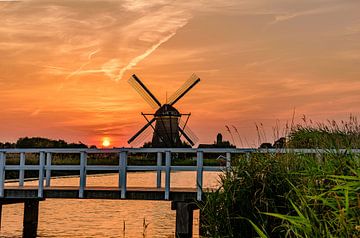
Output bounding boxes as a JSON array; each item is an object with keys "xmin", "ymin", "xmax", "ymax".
[{"xmin": 0, "ymin": 148, "xmax": 360, "ymax": 237}]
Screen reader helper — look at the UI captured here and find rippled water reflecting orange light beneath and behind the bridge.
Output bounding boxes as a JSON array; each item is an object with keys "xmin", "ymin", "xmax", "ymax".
[{"xmin": 1, "ymin": 172, "xmax": 218, "ymax": 237}]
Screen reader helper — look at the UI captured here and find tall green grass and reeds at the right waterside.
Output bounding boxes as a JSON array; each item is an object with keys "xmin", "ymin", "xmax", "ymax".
[{"xmin": 199, "ymin": 117, "xmax": 360, "ymax": 237}]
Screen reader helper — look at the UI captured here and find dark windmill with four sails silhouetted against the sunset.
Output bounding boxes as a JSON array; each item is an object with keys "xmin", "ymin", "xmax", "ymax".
[{"xmin": 128, "ymin": 74, "xmax": 200, "ymax": 148}]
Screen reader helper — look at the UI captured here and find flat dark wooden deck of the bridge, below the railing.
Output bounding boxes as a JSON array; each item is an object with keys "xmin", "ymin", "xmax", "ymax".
[{"xmin": 0, "ymin": 186, "xmax": 202, "ymax": 201}]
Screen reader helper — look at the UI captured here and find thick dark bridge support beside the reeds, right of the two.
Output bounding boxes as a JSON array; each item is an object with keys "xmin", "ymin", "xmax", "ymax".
[{"xmin": 171, "ymin": 201, "xmax": 198, "ymax": 238}]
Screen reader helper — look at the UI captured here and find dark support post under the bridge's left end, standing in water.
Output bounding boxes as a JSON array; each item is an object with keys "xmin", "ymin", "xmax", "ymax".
[{"xmin": 23, "ymin": 199, "xmax": 39, "ymax": 238}]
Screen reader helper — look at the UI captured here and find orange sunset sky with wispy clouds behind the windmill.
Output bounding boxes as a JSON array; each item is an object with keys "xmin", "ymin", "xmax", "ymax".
[{"xmin": 0, "ymin": 0, "xmax": 360, "ymax": 146}]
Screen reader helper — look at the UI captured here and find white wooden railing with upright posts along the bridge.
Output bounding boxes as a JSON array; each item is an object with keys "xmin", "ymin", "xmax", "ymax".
[{"xmin": 0, "ymin": 148, "xmax": 360, "ymax": 200}]
